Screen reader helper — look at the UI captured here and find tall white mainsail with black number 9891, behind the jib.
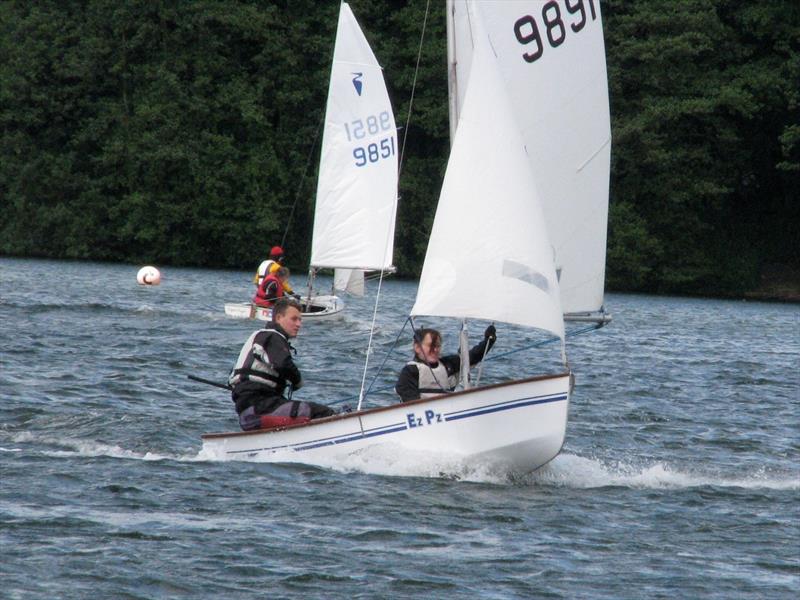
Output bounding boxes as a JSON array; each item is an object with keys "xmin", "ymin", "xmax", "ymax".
[{"xmin": 448, "ymin": 0, "xmax": 611, "ymax": 313}]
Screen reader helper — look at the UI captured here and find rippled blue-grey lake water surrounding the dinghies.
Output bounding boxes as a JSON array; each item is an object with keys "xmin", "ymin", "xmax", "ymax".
[{"xmin": 0, "ymin": 259, "xmax": 800, "ymax": 599}]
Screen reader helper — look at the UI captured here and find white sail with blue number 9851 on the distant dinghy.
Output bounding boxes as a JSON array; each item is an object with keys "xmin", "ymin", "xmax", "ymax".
[{"xmin": 311, "ymin": 3, "xmax": 399, "ymax": 270}]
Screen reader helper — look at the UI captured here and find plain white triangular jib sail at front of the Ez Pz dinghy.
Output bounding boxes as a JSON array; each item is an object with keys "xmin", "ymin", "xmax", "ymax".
[{"xmin": 411, "ymin": 14, "xmax": 564, "ymax": 339}]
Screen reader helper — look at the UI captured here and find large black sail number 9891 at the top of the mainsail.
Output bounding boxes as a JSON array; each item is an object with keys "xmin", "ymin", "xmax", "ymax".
[{"xmin": 514, "ymin": 0, "xmax": 597, "ymax": 62}]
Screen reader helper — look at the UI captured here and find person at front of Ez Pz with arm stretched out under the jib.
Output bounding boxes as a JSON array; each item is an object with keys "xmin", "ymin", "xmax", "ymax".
[{"xmin": 394, "ymin": 325, "xmax": 497, "ymax": 402}]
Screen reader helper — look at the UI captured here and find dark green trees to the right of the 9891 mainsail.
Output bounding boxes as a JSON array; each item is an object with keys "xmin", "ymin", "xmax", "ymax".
[{"xmin": 604, "ymin": 0, "xmax": 800, "ymax": 294}]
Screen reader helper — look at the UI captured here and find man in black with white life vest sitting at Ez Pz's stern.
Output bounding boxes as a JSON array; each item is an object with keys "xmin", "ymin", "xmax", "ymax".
[{"xmin": 228, "ymin": 298, "xmax": 336, "ymax": 431}]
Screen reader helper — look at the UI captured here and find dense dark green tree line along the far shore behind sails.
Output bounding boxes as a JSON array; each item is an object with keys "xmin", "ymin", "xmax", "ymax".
[{"xmin": 0, "ymin": 0, "xmax": 800, "ymax": 295}]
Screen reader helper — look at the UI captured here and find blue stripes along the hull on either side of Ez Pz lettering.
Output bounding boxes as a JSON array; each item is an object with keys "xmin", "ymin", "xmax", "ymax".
[{"xmin": 222, "ymin": 393, "xmax": 567, "ymax": 454}]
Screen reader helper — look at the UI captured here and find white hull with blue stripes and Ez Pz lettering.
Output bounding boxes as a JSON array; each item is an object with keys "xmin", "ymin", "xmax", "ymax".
[{"xmin": 202, "ymin": 373, "xmax": 570, "ymax": 472}]
